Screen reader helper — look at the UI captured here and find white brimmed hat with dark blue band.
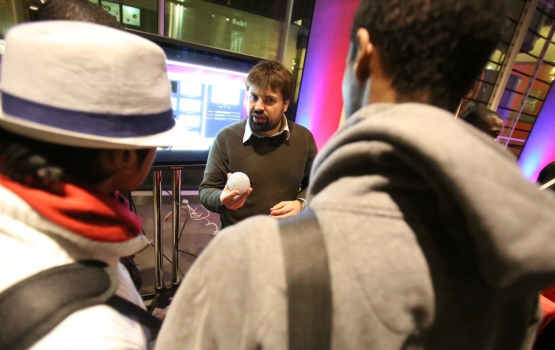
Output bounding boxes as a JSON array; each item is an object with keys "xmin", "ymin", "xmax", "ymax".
[{"xmin": 0, "ymin": 21, "xmax": 183, "ymax": 149}]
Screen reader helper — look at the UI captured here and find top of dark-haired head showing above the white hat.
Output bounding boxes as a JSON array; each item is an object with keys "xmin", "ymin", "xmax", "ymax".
[{"xmin": 31, "ymin": 0, "xmax": 124, "ymax": 29}]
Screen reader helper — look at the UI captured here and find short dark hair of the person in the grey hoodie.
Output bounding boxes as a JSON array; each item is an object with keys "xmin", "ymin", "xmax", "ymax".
[{"xmin": 350, "ymin": 0, "xmax": 506, "ymax": 112}]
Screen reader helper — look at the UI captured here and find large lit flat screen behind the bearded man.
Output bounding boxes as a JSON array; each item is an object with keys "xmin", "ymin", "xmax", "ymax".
[{"xmin": 129, "ymin": 30, "xmax": 260, "ymax": 166}]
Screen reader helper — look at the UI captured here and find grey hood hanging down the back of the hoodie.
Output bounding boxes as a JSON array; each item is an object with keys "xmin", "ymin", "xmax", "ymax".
[{"xmin": 308, "ymin": 103, "xmax": 555, "ymax": 292}]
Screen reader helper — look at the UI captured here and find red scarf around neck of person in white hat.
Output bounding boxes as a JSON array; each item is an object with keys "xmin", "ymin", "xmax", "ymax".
[{"xmin": 0, "ymin": 176, "xmax": 141, "ymax": 242}]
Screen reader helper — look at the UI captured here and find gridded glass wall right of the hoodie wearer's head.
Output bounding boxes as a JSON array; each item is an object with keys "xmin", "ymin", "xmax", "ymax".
[{"xmin": 459, "ymin": 0, "xmax": 555, "ymax": 156}]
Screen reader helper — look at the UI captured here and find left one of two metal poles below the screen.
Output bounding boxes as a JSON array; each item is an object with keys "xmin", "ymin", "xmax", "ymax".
[{"xmin": 152, "ymin": 170, "xmax": 164, "ymax": 293}]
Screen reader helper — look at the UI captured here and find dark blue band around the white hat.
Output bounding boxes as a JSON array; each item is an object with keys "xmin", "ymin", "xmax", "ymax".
[{"xmin": 2, "ymin": 93, "xmax": 175, "ymax": 138}]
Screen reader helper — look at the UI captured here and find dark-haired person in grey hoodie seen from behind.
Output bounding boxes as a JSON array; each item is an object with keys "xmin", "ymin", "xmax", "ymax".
[{"xmin": 157, "ymin": 0, "xmax": 555, "ymax": 350}]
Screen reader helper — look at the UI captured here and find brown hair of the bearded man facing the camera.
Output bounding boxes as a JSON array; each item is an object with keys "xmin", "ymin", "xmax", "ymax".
[{"xmin": 245, "ymin": 60, "xmax": 294, "ymax": 101}]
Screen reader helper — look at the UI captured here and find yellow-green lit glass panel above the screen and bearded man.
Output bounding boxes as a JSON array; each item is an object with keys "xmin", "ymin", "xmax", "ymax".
[{"xmin": 163, "ymin": 0, "xmax": 314, "ymax": 119}]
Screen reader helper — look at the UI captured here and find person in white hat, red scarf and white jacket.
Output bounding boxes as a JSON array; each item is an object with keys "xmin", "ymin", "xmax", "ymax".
[{"xmin": 0, "ymin": 21, "xmax": 182, "ymax": 349}]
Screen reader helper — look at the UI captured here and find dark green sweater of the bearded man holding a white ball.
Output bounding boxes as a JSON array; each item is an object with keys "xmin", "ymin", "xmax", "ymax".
[{"xmin": 199, "ymin": 119, "xmax": 317, "ymax": 228}]
